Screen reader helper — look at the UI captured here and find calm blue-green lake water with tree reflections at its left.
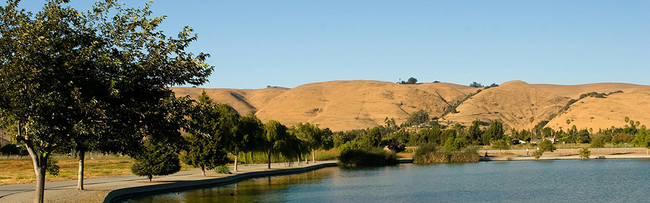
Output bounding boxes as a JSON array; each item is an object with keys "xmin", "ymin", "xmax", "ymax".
[{"xmin": 129, "ymin": 159, "xmax": 650, "ymax": 202}]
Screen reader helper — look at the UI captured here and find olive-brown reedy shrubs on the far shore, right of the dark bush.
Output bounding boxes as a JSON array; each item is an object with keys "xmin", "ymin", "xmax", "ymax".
[{"xmin": 413, "ymin": 145, "xmax": 479, "ymax": 164}]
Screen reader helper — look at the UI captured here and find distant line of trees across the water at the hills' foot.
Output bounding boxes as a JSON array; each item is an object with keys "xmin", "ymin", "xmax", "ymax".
[{"xmin": 334, "ymin": 110, "xmax": 650, "ymax": 155}]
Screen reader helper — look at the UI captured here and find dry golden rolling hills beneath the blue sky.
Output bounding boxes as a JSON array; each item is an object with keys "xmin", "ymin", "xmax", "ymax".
[{"xmin": 173, "ymin": 80, "xmax": 650, "ymax": 131}]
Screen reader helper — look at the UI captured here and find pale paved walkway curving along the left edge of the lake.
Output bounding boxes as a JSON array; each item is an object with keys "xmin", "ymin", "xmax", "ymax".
[{"xmin": 0, "ymin": 161, "xmax": 336, "ymax": 202}]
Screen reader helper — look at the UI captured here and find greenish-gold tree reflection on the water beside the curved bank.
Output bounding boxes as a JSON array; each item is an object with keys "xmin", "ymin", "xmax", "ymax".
[{"xmin": 135, "ymin": 167, "xmax": 339, "ymax": 202}]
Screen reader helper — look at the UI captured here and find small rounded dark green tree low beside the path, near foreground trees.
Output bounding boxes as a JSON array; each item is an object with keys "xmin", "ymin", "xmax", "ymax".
[{"xmin": 131, "ymin": 143, "xmax": 181, "ymax": 181}]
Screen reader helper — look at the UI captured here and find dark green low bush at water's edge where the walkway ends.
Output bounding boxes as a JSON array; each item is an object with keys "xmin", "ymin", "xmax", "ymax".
[{"xmin": 339, "ymin": 148, "xmax": 397, "ymax": 167}]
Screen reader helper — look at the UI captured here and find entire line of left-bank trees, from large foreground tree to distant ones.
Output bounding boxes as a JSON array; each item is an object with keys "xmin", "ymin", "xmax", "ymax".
[{"xmin": 0, "ymin": 0, "xmax": 334, "ymax": 202}]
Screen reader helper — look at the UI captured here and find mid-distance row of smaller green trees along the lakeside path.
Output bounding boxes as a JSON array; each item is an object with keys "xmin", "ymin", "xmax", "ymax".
[{"xmin": 127, "ymin": 92, "xmax": 332, "ymax": 180}]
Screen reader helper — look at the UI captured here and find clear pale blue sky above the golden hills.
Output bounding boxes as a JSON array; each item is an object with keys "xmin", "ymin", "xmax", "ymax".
[{"xmin": 10, "ymin": 0, "xmax": 650, "ymax": 89}]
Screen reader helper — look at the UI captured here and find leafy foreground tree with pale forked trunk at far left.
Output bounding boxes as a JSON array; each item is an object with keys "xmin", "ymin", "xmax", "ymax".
[{"xmin": 0, "ymin": 0, "xmax": 104, "ymax": 202}]
